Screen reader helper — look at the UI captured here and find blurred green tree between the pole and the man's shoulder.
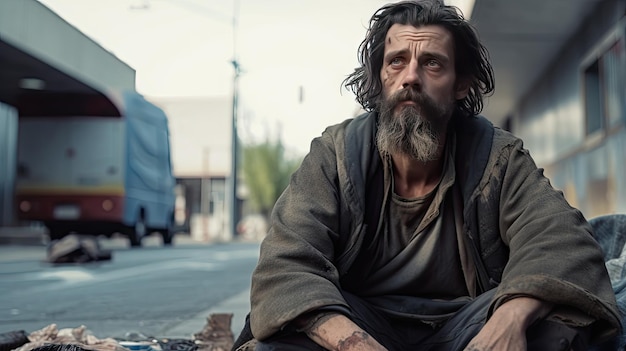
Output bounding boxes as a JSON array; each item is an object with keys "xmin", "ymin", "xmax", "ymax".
[{"xmin": 243, "ymin": 140, "xmax": 302, "ymax": 218}]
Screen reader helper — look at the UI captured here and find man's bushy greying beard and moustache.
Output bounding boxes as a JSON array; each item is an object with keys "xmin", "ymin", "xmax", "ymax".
[{"xmin": 376, "ymin": 91, "xmax": 454, "ymax": 162}]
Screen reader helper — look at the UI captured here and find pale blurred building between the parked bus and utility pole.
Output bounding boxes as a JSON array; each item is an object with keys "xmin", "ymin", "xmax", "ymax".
[{"xmin": 150, "ymin": 96, "xmax": 235, "ymax": 241}]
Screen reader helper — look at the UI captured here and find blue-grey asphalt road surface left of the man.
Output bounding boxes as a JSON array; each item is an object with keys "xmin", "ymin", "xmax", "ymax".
[{"xmin": 0, "ymin": 239, "xmax": 259, "ymax": 339}]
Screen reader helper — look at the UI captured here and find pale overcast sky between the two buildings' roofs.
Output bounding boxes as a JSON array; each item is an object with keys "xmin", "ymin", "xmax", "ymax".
[{"xmin": 39, "ymin": 0, "xmax": 473, "ymax": 154}]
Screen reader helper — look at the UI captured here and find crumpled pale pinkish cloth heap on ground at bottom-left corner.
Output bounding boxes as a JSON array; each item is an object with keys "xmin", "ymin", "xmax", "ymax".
[{"xmin": 13, "ymin": 324, "xmax": 129, "ymax": 351}]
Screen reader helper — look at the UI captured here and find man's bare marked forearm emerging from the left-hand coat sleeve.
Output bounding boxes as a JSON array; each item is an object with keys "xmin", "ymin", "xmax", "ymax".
[{"xmin": 306, "ymin": 314, "xmax": 387, "ymax": 351}]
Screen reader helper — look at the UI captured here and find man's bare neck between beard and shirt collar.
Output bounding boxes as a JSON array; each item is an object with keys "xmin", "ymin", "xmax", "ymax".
[{"xmin": 391, "ymin": 147, "xmax": 445, "ymax": 199}]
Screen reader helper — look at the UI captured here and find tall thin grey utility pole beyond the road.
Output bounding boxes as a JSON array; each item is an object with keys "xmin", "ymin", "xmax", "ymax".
[{"xmin": 230, "ymin": 0, "xmax": 241, "ymax": 237}]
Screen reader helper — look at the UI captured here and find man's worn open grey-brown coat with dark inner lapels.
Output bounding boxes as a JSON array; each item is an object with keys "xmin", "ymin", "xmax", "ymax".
[{"xmin": 250, "ymin": 112, "xmax": 621, "ymax": 346}]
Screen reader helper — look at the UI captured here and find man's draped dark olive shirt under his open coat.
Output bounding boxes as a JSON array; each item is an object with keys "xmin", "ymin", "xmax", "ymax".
[{"xmin": 355, "ymin": 138, "xmax": 469, "ymax": 302}]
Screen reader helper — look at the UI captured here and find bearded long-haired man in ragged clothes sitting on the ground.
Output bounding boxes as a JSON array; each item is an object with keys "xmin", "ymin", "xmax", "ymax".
[{"xmin": 233, "ymin": 0, "xmax": 621, "ymax": 351}]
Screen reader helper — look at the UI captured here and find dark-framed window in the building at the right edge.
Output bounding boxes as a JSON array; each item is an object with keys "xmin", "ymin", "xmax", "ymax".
[{"xmin": 584, "ymin": 38, "xmax": 626, "ymax": 135}]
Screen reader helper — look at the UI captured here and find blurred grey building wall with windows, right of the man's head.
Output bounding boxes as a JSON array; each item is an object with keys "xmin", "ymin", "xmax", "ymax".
[{"xmin": 510, "ymin": 1, "xmax": 626, "ymax": 218}]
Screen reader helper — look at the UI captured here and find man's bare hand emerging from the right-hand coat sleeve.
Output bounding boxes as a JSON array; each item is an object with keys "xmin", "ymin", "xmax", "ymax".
[{"xmin": 464, "ymin": 297, "xmax": 552, "ymax": 351}]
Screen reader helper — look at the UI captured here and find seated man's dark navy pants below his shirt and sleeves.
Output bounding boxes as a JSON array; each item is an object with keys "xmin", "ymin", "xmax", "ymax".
[{"xmin": 251, "ymin": 291, "xmax": 587, "ymax": 351}]
